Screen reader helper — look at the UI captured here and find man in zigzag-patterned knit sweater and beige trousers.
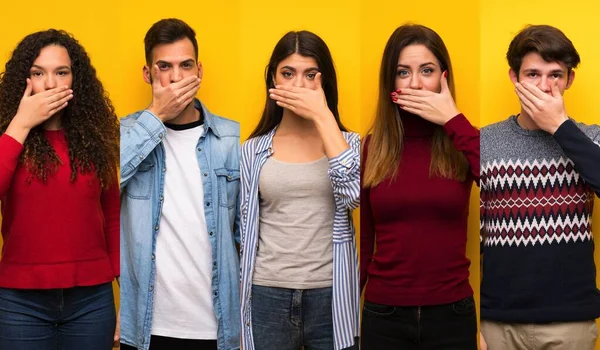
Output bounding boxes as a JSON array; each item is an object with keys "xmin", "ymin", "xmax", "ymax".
[{"xmin": 481, "ymin": 25, "xmax": 600, "ymax": 350}]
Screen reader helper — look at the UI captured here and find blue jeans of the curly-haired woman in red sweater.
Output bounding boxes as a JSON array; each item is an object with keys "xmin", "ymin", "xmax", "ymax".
[{"xmin": 0, "ymin": 283, "xmax": 116, "ymax": 350}]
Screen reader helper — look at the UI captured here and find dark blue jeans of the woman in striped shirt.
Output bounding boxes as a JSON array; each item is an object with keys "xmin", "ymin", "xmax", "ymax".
[{"xmin": 252, "ymin": 285, "xmax": 358, "ymax": 350}]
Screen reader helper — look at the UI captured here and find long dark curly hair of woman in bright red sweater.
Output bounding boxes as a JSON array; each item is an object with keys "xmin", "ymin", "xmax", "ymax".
[{"xmin": 0, "ymin": 29, "xmax": 119, "ymax": 188}]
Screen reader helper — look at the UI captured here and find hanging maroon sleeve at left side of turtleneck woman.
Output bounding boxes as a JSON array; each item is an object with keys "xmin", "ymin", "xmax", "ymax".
[{"xmin": 360, "ymin": 136, "xmax": 375, "ymax": 292}]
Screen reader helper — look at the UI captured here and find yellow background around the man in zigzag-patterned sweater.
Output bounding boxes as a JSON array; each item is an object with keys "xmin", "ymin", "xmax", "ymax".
[{"xmin": 480, "ymin": 0, "xmax": 600, "ymax": 349}]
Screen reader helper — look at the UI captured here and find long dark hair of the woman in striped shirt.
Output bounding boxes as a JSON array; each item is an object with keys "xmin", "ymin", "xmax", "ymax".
[{"xmin": 249, "ymin": 30, "xmax": 348, "ymax": 138}]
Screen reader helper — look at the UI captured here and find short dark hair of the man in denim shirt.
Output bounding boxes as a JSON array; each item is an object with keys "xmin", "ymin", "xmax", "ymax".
[{"xmin": 144, "ymin": 18, "xmax": 198, "ymax": 64}]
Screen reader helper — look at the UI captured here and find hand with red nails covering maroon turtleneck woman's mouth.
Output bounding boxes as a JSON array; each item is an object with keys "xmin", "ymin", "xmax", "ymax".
[{"xmin": 392, "ymin": 71, "xmax": 460, "ymax": 125}]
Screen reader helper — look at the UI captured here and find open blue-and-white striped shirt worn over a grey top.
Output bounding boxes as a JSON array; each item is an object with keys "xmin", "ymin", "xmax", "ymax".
[{"xmin": 240, "ymin": 128, "xmax": 360, "ymax": 350}]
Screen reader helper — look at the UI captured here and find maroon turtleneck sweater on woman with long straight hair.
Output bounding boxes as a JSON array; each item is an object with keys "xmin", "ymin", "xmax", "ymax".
[{"xmin": 360, "ymin": 114, "xmax": 479, "ymax": 306}]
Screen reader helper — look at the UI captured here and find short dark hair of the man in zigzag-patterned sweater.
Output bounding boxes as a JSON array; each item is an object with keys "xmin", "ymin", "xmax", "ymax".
[{"xmin": 506, "ymin": 25, "xmax": 580, "ymax": 75}]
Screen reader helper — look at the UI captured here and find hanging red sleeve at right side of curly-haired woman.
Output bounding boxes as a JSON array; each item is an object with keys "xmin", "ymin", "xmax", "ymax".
[{"xmin": 101, "ymin": 176, "xmax": 121, "ymax": 277}]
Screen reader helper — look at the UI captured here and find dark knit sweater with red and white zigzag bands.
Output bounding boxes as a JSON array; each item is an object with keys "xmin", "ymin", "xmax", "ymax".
[{"xmin": 480, "ymin": 116, "xmax": 600, "ymax": 323}]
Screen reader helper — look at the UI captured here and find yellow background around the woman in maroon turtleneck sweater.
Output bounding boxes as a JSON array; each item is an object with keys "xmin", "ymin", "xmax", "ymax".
[{"xmin": 360, "ymin": 0, "xmax": 480, "ymax": 332}]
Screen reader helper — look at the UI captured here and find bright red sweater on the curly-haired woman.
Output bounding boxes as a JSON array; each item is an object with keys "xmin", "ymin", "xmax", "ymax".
[{"xmin": 0, "ymin": 130, "xmax": 119, "ymax": 289}]
